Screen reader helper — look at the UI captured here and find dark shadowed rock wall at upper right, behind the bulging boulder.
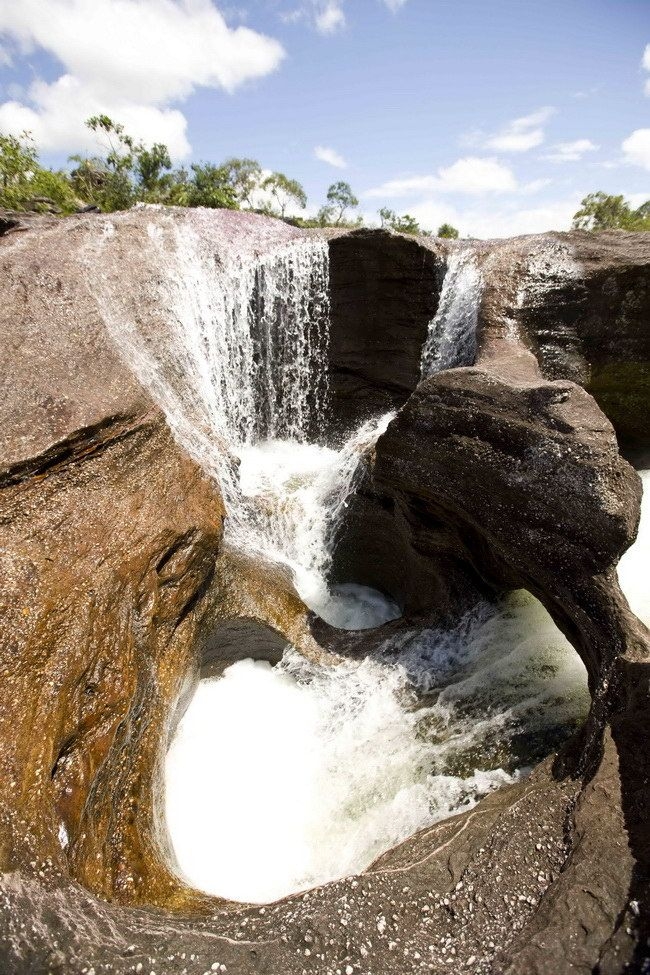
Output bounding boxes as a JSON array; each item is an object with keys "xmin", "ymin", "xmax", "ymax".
[{"xmin": 478, "ymin": 231, "xmax": 650, "ymax": 450}]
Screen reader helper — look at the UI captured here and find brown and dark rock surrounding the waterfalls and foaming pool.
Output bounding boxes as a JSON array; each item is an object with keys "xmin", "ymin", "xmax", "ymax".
[{"xmin": 0, "ymin": 211, "xmax": 650, "ymax": 975}]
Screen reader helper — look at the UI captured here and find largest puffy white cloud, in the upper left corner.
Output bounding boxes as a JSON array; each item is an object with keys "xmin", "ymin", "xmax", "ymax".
[{"xmin": 0, "ymin": 0, "xmax": 284, "ymax": 156}]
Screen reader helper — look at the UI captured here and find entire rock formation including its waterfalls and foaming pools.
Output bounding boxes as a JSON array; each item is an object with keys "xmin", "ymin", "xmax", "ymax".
[{"xmin": 0, "ymin": 209, "xmax": 650, "ymax": 975}]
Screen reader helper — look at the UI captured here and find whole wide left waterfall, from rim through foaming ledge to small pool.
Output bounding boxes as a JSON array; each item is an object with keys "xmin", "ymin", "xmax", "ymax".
[{"xmin": 88, "ymin": 211, "xmax": 392, "ymax": 626}]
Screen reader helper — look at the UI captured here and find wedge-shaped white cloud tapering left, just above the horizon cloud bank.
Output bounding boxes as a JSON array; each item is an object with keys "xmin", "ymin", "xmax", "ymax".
[{"xmin": 364, "ymin": 156, "xmax": 517, "ymax": 197}]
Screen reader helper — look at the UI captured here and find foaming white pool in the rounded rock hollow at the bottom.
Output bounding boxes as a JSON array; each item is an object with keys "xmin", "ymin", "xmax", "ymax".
[{"xmin": 167, "ymin": 593, "xmax": 589, "ymax": 902}]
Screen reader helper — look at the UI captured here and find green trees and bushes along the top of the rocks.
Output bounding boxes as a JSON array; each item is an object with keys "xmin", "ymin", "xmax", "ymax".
[{"xmin": 0, "ymin": 115, "xmax": 650, "ymax": 238}]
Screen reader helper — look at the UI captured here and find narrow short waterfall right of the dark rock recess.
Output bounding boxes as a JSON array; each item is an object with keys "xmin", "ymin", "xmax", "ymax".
[{"xmin": 421, "ymin": 247, "xmax": 482, "ymax": 378}]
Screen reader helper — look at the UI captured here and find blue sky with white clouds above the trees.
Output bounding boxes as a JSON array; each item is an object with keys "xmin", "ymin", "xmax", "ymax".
[{"xmin": 0, "ymin": 0, "xmax": 650, "ymax": 237}]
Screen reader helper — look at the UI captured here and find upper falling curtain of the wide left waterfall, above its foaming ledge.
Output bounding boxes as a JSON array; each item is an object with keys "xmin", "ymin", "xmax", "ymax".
[{"xmin": 89, "ymin": 214, "xmax": 329, "ymax": 488}]
